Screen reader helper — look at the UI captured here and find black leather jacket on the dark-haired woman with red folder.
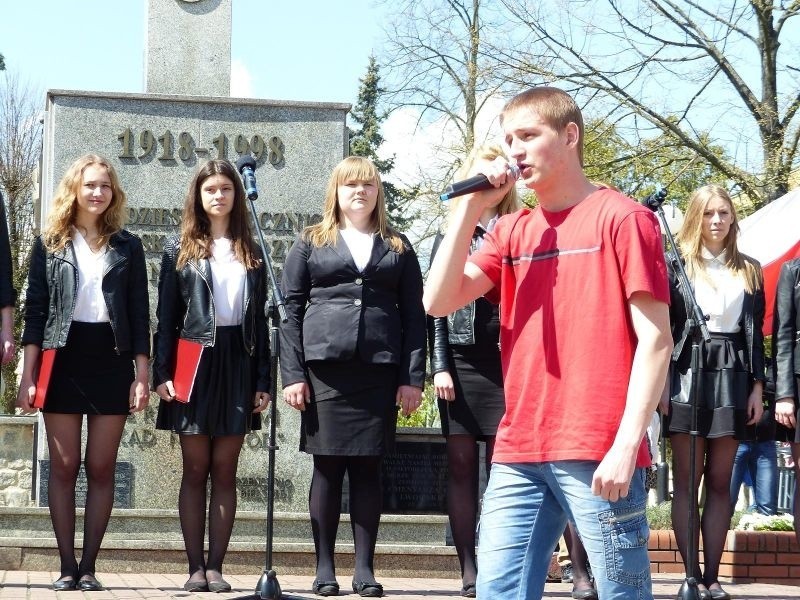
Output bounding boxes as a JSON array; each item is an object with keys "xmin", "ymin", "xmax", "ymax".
[{"xmin": 153, "ymin": 236, "xmax": 270, "ymax": 392}]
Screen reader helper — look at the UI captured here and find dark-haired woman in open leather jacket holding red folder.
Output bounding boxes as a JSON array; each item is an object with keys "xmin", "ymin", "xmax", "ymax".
[{"xmin": 153, "ymin": 160, "xmax": 270, "ymax": 592}]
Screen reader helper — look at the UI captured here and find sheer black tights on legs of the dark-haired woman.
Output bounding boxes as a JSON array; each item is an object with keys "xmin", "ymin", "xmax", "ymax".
[{"xmin": 178, "ymin": 435, "xmax": 244, "ymax": 580}]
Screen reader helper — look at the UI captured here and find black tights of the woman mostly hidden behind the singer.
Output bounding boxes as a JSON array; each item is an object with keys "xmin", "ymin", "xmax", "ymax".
[{"xmin": 447, "ymin": 434, "xmax": 494, "ymax": 584}]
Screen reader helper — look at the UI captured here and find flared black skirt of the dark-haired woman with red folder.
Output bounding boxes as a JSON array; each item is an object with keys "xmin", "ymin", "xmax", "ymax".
[{"xmin": 156, "ymin": 325, "xmax": 261, "ymax": 436}]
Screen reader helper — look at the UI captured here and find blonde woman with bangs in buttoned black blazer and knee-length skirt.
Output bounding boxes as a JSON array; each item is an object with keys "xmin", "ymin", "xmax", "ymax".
[{"xmin": 281, "ymin": 157, "xmax": 425, "ymax": 597}]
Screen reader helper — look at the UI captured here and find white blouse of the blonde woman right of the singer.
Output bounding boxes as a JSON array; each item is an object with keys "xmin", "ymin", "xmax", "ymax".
[{"xmin": 692, "ymin": 248, "xmax": 744, "ymax": 333}]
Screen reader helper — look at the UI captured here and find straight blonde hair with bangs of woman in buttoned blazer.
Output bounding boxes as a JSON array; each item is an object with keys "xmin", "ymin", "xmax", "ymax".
[{"xmin": 303, "ymin": 156, "xmax": 405, "ymax": 254}]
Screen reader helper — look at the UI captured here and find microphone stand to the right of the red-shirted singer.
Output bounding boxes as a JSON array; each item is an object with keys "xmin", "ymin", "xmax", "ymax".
[{"xmin": 642, "ymin": 189, "xmax": 711, "ymax": 600}]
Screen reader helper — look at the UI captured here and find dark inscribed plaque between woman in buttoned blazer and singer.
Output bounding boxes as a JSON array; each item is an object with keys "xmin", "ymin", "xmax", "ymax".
[{"xmin": 382, "ymin": 438, "xmax": 447, "ymax": 514}]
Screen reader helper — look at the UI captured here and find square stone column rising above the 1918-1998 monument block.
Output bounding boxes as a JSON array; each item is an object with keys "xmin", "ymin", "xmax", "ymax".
[{"xmin": 144, "ymin": 0, "xmax": 232, "ymax": 97}]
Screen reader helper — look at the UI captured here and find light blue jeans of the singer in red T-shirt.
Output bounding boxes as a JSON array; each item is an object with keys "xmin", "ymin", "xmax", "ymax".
[{"xmin": 478, "ymin": 461, "xmax": 653, "ymax": 600}]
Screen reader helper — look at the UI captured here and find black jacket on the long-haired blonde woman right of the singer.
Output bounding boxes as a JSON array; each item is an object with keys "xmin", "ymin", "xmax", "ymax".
[{"xmin": 667, "ymin": 251, "xmax": 766, "ymax": 382}]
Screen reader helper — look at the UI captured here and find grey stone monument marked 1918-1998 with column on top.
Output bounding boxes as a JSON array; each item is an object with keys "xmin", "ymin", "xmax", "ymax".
[{"xmin": 36, "ymin": 0, "xmax": 350, "ymax": 512}]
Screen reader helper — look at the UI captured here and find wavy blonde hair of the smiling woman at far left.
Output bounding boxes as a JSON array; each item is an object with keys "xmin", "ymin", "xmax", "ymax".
[{"xmin": 42, "ymin": 154, "xmax": 127, "ymax": 252}]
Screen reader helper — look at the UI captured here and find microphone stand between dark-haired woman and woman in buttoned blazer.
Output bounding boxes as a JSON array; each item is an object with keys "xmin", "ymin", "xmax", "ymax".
[{"xmin": 246, "ymin": 162, "xmax": 286, "ymax": 600}]
